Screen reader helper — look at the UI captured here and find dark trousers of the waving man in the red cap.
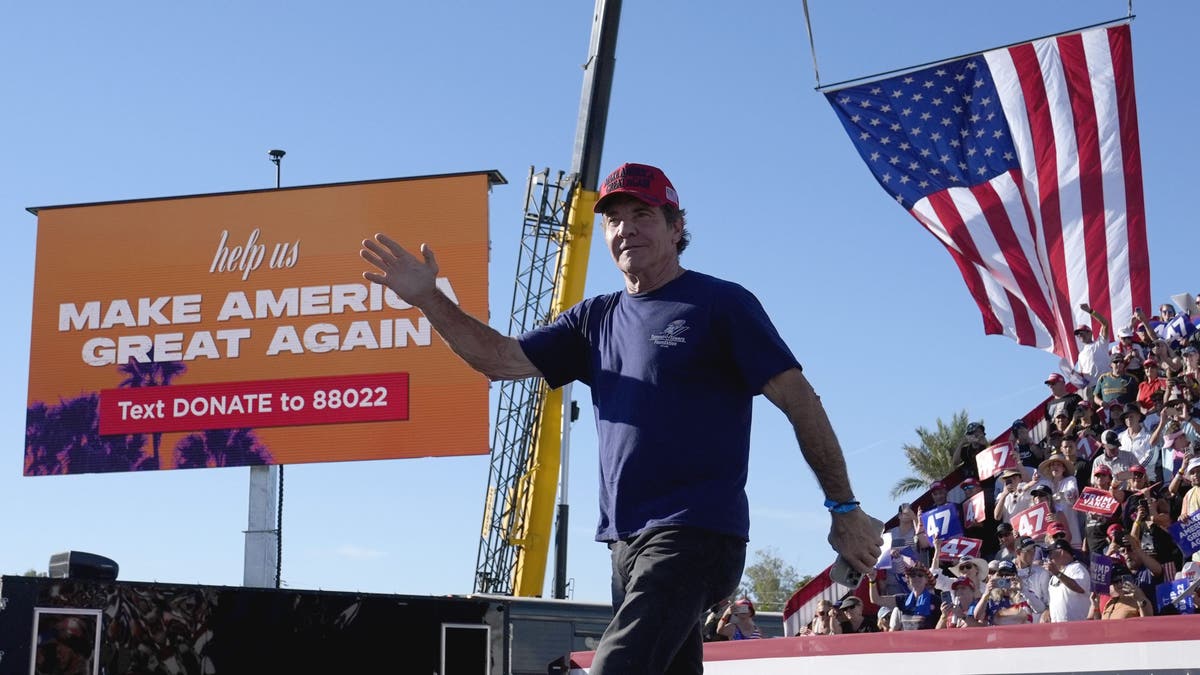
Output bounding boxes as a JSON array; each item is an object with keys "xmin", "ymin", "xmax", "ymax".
[{"xmin": 589, "ymin": 527, "xmax": 746, "ymax": 675}]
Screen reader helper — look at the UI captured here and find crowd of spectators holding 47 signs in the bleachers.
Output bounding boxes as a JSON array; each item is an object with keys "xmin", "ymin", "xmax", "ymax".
[{"xmin": 706, "ymin": 297, "xmax": 1200, "ymax": 639}]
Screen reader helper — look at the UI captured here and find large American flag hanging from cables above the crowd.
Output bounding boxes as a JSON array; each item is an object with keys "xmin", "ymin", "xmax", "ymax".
[{"xmin": 826, "ymin": 24, "xmax": 1150, "ymax": 363}]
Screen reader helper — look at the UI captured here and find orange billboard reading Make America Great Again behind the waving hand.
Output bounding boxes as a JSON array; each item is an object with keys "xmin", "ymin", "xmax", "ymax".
[{"xmin": 24, "ymin": 172, "xmax": 504, "ymax": 476}]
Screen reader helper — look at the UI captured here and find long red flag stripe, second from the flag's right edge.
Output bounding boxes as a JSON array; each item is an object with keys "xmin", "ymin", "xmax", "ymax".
[{"xmin": 1057, "ymin": 34, "xmax": 1112, "ymax": 333}]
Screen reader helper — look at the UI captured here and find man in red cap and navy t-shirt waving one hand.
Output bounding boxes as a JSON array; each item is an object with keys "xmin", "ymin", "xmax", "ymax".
[{"xmin": 361, "ymin": 163, "xmax": 882, "ymax": 675}]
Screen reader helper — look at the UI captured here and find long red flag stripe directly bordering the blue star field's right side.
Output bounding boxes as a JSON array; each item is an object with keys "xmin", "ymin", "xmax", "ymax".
[{"xmin": 1008, "ymin": 44, "xmax": 1074, "ymax": 357}]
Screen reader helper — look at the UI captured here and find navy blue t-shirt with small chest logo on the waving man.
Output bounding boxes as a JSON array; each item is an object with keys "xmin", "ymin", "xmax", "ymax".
[{"xmin": 518, "ymin": 271, "xmax": 799, "ymax": 542}]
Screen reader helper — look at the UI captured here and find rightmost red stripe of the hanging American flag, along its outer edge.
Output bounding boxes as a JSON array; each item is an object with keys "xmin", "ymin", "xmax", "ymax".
[{"xmin": 1108, "ymin": 24, "xmax": 1151, "ymax": 307}]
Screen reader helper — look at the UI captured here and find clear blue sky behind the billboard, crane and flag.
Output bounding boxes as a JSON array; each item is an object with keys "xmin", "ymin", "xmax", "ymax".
[{"xmin": 0, "ymin": 0, "xmax": 1200, "ymax": 601}]
